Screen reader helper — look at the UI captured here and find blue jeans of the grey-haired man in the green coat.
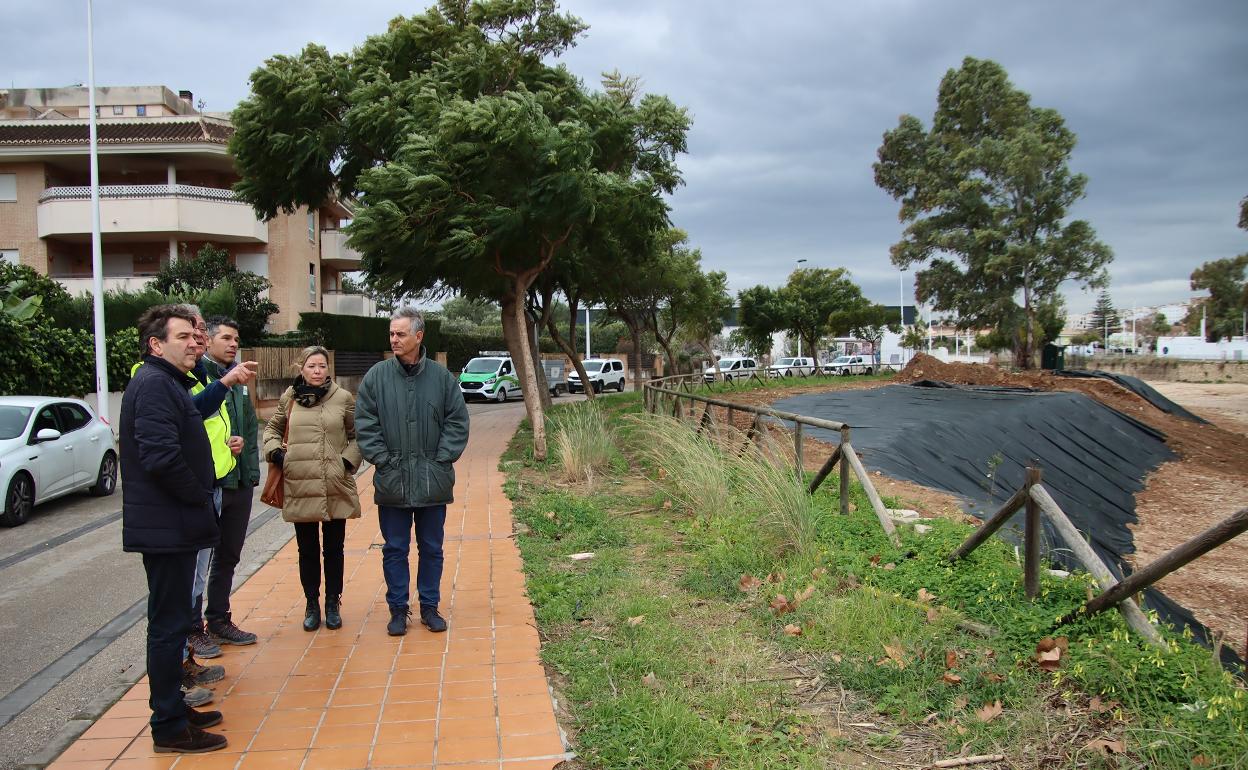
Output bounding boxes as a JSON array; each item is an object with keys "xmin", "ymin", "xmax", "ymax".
[{"xmin": 377, "ymin": 505, "xmax": 447, "ymax": 609}]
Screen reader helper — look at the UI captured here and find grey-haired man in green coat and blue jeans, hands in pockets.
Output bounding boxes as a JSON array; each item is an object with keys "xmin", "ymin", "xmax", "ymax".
[{"xmin": 356, "ymin": 307, "xmax": 468, "ymax": 636}]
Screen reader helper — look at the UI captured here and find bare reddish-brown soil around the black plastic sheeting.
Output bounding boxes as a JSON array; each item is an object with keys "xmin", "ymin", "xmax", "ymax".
[{"xmin": 708, "ymin": 354, "xmax": 1248, "ymax": 653}]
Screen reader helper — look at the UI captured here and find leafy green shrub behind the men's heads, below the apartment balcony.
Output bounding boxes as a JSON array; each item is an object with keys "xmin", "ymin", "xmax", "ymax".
[{"xmin": 151, "ymin": 243, "xmax": 278, "ymax": 343}]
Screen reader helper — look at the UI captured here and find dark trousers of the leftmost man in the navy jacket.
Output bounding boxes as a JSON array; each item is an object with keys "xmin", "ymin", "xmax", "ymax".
[{"xmin": 144, "ymin": 550, "xmax": 195, "ymax": 739}]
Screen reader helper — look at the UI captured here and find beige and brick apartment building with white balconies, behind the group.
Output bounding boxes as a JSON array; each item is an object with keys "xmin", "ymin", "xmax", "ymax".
[{"xmin": 0, "ymin": 86, "xmax": 374, "ymax": 332}]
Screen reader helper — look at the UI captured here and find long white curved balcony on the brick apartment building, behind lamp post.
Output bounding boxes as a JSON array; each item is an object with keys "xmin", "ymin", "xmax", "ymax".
[{"xmin": 37, "ymin": 185, "xmax": 268, "ymax": 243}]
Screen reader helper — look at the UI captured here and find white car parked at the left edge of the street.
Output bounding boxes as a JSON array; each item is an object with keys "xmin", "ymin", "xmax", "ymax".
[{"xmin": 0, "ymin": 396, "xmax": 117, "ymax": 527}]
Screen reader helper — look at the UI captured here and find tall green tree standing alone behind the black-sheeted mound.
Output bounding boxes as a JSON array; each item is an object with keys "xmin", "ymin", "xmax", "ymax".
[{"xmin": 874, "ymin": 57, "xmax": 1112, "ymax": 367}]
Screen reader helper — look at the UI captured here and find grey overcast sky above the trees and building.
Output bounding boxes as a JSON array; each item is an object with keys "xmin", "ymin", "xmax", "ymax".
[{"xmin": 0, "ymin": 0, "xmax": 1248, "ymax": 312}]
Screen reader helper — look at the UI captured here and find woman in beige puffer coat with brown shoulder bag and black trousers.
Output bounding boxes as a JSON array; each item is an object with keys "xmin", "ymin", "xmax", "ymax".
[{"xmin": 265, "ymin": 346, "xmax": 363, "ymax": 631}]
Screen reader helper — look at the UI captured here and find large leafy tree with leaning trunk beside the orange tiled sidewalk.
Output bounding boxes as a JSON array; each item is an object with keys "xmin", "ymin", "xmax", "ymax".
[{"xmin": 231, "ymin": 0, "xmax": 689, "ymax": 458}]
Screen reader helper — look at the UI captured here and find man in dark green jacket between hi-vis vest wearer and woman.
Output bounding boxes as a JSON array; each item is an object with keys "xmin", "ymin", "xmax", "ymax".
[{"xmin": 195, "ymin": 316, "xmax": 260, "ymax": 644}]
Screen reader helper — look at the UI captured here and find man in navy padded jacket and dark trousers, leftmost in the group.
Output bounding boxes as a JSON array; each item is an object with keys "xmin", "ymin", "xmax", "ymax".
[{"xmin": 119, "ymin": 305, "xmax": 226, "ymax": 753}]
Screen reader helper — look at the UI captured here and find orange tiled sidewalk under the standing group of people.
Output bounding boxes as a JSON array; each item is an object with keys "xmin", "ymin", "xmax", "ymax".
[{"xmin": 50, "ymin": 408, "xmax": 569, "ymax": 770}]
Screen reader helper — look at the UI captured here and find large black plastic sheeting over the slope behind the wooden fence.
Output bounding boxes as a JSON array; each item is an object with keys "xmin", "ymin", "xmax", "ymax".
[{"xmin": 774, "ymin": 381, "xmax": 1239, "ymax": 665}]
